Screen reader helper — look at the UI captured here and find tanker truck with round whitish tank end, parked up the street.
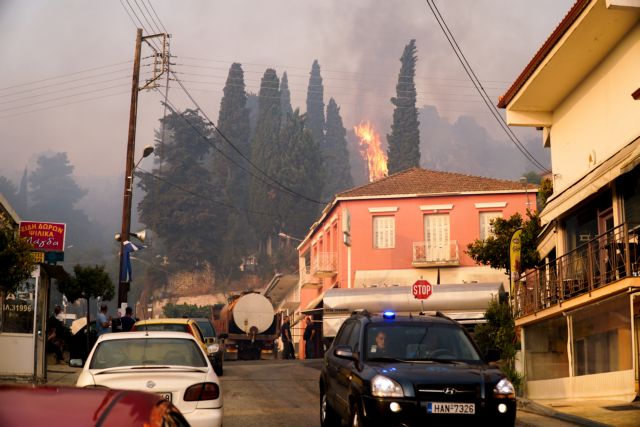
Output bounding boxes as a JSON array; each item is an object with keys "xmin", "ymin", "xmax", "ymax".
[{"xmin": 213, "ymin": 292, "xmax": 279, "ymax": 360}]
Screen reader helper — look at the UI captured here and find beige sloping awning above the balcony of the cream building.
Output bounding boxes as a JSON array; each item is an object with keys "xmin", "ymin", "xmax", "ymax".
[{"xmin": 540, "ymin": 138, "xmax": 640, "ymax": 224}]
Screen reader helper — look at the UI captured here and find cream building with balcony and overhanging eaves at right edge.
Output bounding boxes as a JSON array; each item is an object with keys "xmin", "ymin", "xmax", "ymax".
[{"xmin": 498, "ymin": 0, "xmax": 640, "ymax": 401}]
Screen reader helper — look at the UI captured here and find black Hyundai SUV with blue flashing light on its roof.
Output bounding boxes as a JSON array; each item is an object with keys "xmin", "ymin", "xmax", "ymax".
[{"xmin": 320, "ymin": 312, "xmax": 516, "ymax": 427}]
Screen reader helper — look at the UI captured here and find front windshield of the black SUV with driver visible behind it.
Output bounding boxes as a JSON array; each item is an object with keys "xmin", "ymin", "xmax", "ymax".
[{"xmin": 365, "ymin": 322, "xmax": 481, "ymax": 362}]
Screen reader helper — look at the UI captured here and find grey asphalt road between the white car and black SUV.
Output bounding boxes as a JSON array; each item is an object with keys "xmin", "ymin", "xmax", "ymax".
[{"xmin": 222, "ymin": 359, "xmax": 574, "ymax": 427}]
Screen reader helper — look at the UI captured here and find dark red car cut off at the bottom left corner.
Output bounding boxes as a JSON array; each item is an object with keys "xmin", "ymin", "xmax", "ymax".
[{"xmin": 0, "ymin": 385, "xmax": 189, "ymax": 427}]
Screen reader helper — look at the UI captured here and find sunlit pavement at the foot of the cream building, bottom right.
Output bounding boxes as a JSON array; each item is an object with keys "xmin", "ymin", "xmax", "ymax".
[{"xmin": 518, "ymin": 398, "xmax": 640, "ymax": 427}]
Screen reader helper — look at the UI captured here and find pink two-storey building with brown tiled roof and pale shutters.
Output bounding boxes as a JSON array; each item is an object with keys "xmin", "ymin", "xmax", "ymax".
[{"xmin": 298, "ymin": 168, "xmax": 537, "ymax": 354}]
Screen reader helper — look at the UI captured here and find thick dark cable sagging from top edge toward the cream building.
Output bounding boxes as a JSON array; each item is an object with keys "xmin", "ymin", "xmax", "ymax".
[{"xmin": 426, "ymin": 0, "xmax": 551, "ymax": 173}]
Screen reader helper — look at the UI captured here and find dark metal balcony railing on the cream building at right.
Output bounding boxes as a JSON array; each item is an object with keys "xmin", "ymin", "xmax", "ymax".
[{"xmin": 514, "ymin": 223, "xmax": 640, "ymax": 317}]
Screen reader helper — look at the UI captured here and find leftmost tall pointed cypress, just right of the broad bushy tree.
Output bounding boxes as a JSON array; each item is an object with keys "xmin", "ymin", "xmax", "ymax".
[{"xmin": 213, "ymin": 63, "xmax": 251, "ymax": 272}]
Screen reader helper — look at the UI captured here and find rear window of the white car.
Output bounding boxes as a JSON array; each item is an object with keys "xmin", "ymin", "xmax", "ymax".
[{"xmin": 89, "ymin": 338, "xmax": 207, "ymax": 369}]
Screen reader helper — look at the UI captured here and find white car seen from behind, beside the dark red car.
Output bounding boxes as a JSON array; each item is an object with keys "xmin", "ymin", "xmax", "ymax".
[{"xmin": 76, "ymin": 331, "xmax": 222, "ymax": 427}]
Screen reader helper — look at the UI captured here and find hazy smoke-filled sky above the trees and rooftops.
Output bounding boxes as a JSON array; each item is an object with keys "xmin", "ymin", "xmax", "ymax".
[{"xmin": 0, "ymin": 0, "xmax": 572, "ymax": 189}]
